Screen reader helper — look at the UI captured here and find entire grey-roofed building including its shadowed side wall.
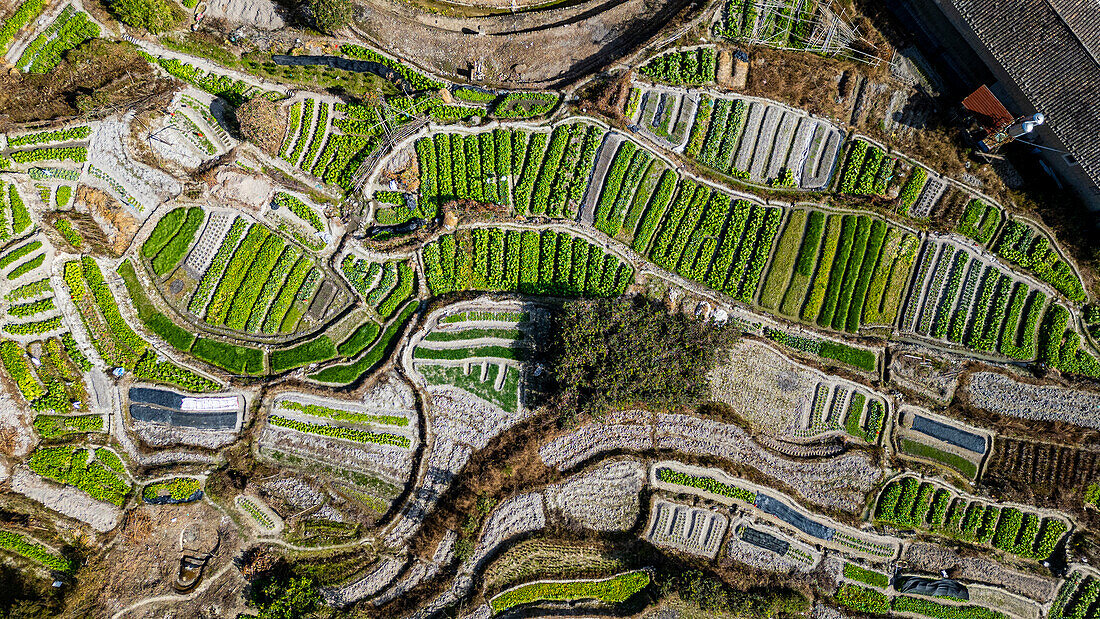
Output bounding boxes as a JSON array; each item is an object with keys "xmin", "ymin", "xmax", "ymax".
[{"xmin": 933, "ymin": 0, "xmax": 1100, "ymax": 211}]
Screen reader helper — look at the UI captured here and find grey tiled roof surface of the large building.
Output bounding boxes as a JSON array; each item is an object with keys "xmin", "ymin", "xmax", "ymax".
[{"xmin": 949, "ymin": 0, "xmax": 1100, "ymax": 186}]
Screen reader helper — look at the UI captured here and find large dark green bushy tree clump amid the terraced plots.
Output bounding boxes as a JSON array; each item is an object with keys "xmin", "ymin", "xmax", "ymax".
[{"xmin": 549, "ymin": 298, "xmax": 734, "ymax": 412}]
